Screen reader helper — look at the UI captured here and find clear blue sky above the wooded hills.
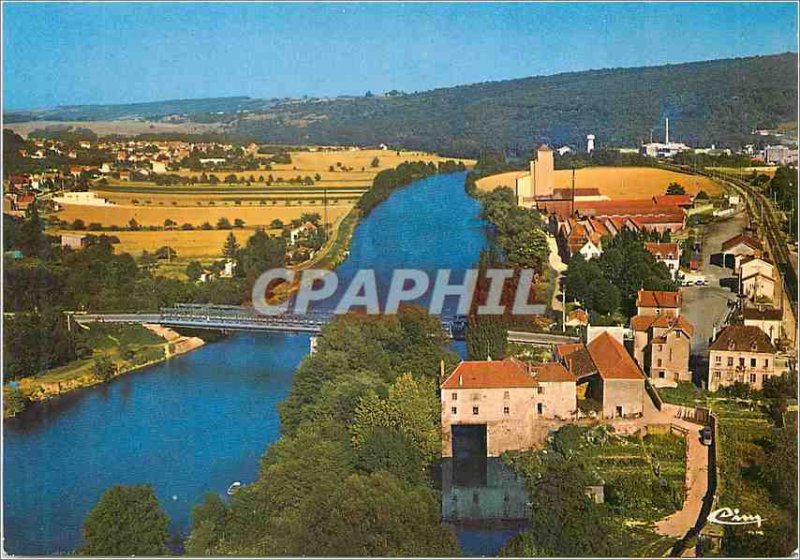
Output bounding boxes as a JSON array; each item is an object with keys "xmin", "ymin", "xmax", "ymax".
[{"xmin": 3, "ymin": 2, "xmax": 798, "ymax": 110}]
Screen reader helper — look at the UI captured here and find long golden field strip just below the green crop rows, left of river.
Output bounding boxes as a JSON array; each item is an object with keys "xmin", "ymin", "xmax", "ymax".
[{"xmin": 53, "ymin": 199, "xmax": 352, "ymax": 230}]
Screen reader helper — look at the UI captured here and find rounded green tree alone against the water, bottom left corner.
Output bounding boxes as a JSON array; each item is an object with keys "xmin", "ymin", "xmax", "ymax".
[{"xmin": 81, "ymin": 485, "xmax": 169, "ymax": 556}]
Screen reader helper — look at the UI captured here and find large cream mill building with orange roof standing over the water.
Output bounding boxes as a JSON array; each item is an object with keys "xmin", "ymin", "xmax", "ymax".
[{"xmin": 441, "ymin": 360, "xmax": 577, "ymax": 457}]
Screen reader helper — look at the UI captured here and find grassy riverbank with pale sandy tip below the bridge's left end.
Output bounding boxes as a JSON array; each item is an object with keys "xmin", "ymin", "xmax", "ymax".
[{"xmin": 3, "ymin": 325, "xmax": 205, "ymax": 418}]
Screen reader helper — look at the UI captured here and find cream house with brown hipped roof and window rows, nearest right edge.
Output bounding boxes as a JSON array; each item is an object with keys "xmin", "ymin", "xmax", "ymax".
[{"xmin": 706, "ymin": 325, "xmax": 776, "ymax": 391}]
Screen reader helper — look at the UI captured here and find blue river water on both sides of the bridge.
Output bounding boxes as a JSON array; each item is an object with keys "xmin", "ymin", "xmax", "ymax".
[{"xmin": 3, "ymin": 174, "xmax": 520, "ymax": 555}]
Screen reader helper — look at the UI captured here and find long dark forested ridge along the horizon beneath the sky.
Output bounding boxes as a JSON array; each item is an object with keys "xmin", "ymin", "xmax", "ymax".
[{"xmin": 9, "ymin": 53, "xmax": 797, "ymax": 156}]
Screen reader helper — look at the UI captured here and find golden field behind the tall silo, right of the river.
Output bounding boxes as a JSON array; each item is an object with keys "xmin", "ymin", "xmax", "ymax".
[{"xmin": 477, "ymin": 167, "xmax": 722, "ymax": 199}]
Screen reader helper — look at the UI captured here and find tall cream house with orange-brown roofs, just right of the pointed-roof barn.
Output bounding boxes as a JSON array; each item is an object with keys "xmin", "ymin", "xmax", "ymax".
[{"xmin": 631, "ymin": 315, "xmax": 694, "ymax": 387}]
